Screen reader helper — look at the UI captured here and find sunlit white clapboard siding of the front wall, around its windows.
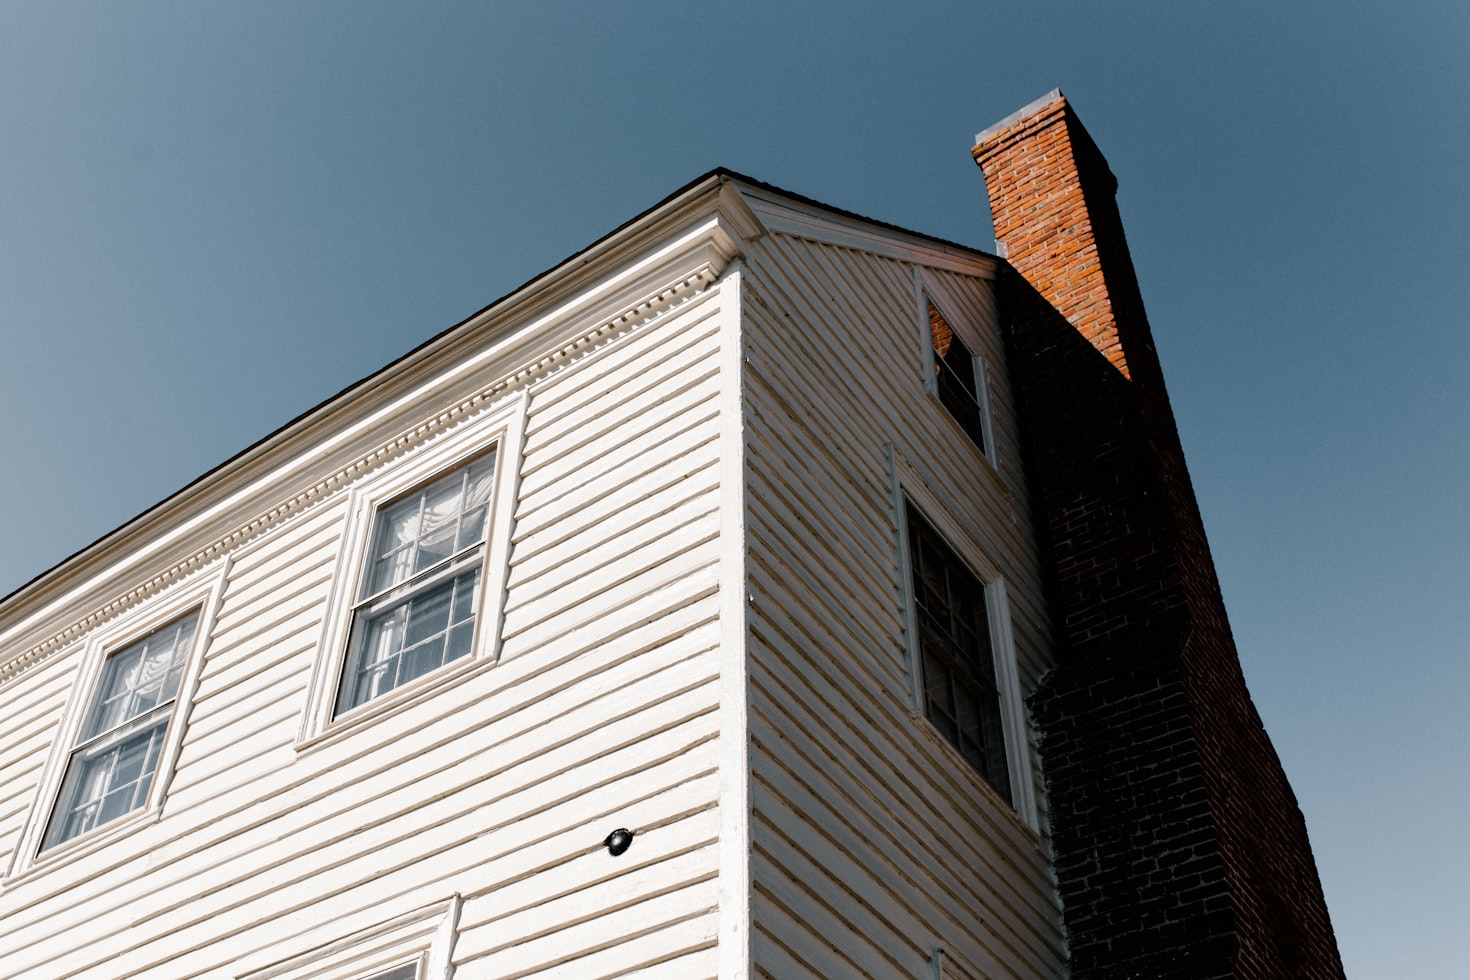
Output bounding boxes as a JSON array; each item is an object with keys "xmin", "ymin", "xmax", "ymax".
[{"xmin": 0, "ymin": 265, "xmax": 735, "ymax": 980}]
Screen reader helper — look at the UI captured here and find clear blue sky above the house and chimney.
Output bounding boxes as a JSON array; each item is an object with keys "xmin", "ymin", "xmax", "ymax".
[{"xmin": 0, "ymin": 0, "xmax": 1470, "ymax": 979}]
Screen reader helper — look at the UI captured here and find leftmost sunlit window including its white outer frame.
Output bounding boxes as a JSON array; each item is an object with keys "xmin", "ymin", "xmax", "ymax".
[{"xmin": 9, "ymin": 563, "xmax": 225, "ymax": 876}]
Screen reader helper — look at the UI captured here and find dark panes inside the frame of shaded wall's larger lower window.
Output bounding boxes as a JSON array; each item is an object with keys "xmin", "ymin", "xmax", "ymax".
[{"xmin": 907, "ymin": 505, "xmax": 1011, "ymax": 802}]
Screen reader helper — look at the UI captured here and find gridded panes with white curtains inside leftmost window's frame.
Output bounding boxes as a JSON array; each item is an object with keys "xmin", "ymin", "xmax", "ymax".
[{"xmin": 41, "ymin": 611, "xmax": 198, "ymax": 851}]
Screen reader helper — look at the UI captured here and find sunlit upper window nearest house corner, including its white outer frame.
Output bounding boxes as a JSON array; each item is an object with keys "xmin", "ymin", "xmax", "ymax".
[{"xmin": 298, "ymin": 401, "xmax": 525, "ymax": 746}]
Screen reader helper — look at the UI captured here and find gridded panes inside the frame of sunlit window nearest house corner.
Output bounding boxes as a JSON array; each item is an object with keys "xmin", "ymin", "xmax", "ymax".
[{"xmin": 337, "ymin": 453, "xmax": 495, "ymax": 714}]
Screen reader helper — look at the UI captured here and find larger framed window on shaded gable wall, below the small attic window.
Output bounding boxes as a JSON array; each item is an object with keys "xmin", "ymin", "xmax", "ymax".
[{"xmin": 889, "ymin": 447, "xmax": 1036, "ymax": 829}]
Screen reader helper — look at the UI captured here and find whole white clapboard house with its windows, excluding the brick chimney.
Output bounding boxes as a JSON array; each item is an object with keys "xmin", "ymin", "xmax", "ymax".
[{"xmin": 0, "ymin": 164, "xmax": 1066, "ymax": 980}]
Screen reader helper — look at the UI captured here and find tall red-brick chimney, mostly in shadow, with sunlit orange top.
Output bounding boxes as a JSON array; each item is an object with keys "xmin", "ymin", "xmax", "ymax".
[{"xmin": 973, "ymin": 91, "xmax": 1342, "ymax": 979}]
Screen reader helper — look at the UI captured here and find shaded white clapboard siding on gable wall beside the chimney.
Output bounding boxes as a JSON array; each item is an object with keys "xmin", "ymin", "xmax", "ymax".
[{"xmin": 744, "ymin": 234, "xmax": 1064, "ymax": 979}]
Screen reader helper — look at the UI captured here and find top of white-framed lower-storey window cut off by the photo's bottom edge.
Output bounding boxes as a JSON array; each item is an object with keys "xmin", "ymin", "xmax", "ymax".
[{"xmin": 237, "ymin": 895, "xmax": 463, "ymax": 980}]
